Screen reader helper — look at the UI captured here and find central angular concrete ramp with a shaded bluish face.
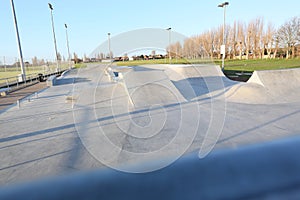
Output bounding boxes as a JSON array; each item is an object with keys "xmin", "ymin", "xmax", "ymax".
[{"xmin": 124, "ymin": 65, "xmax": 234, "ymax": 103}]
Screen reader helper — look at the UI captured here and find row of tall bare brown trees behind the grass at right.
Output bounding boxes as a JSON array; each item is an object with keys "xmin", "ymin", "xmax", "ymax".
[{"xmin": 167, "ymin": 17, "xmax": 300, "ymax": 59}]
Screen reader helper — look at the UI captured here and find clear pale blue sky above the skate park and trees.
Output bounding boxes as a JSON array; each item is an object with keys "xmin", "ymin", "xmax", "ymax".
[{"xmin": 0, "ymin": 0, "xmax": 300, "ymax": 63}]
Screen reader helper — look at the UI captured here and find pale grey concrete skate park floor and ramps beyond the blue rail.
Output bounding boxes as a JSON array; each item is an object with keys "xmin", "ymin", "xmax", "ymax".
[{"xmin": 0, "ymin": 65, "xmax": 300, "ymax": 184}]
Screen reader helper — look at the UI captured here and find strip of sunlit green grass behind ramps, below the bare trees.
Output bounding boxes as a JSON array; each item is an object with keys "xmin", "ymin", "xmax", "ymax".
[{"xmin": 116, "ymin": 58, "xmax": 300, "ymax": 72}]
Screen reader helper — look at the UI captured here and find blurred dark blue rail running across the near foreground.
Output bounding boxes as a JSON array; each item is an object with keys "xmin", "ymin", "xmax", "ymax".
[{"xmin": 0, "ymin": 137, "xmax": 300, "ymax": 200}]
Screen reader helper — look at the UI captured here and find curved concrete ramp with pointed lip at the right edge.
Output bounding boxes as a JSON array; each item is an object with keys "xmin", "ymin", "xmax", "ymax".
[{"xmin": 226, "ymin": 68, "xmax": 300, "ymax": 105}]
